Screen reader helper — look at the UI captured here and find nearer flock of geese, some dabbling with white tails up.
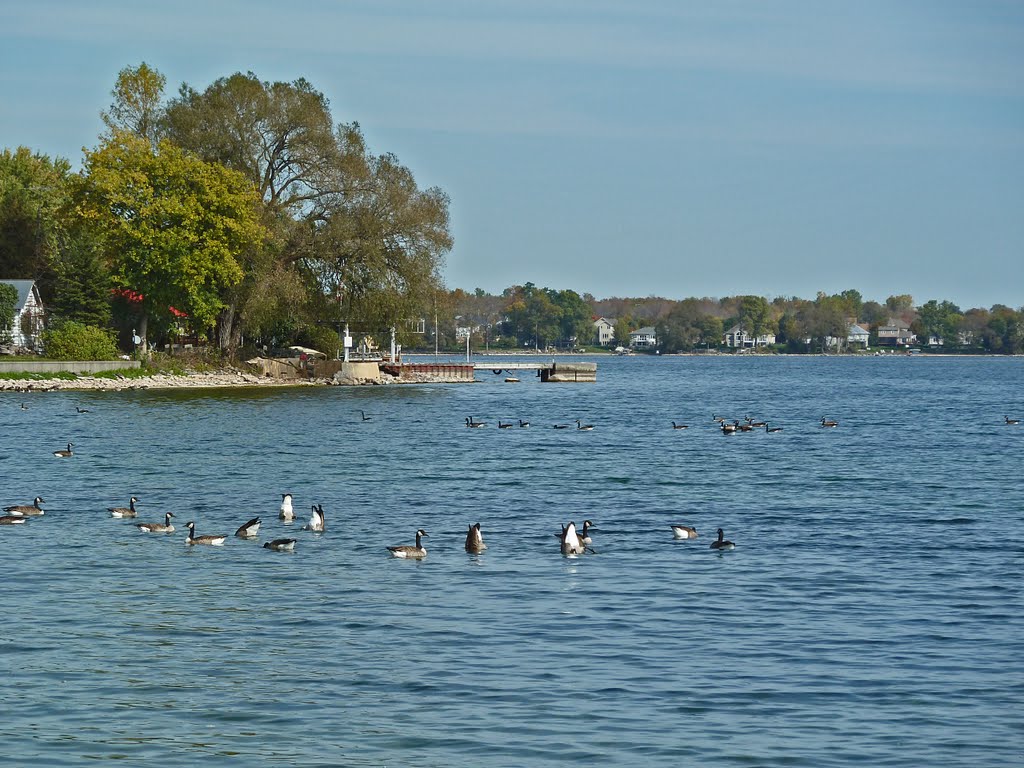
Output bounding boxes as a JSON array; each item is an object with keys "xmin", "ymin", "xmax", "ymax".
[{"xmin": 0, "ymin": 494, "xmax": 736, "ymax": 560}]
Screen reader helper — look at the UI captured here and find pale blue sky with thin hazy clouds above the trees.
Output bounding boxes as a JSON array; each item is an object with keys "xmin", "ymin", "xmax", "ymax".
[{"xmin": 0, "ymin": 0, "xmax": 1024, "ymax": 308}]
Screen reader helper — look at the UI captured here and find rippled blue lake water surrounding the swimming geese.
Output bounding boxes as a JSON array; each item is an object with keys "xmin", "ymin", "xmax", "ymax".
[{"xmin": 0, "ymin": 356, "xmax": 1024, "ymax": 767}]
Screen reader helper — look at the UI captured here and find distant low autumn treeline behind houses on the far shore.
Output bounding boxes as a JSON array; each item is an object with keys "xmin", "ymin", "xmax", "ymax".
[{"xmin": 447, "ymin": 283, "xmax": 1024, "ymax": 354}]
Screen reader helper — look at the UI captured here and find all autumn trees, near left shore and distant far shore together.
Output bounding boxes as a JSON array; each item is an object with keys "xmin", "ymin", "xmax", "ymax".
[{"xmin": 0, "ymin": 63, "xmax": 1024, "ymax": 357}]
